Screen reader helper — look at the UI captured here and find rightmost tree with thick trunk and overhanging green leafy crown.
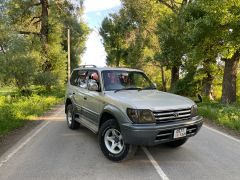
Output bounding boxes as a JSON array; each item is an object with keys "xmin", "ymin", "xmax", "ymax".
[{"xmin": 182, "ymin": 0, "xmax": 240, "ymax": 103}]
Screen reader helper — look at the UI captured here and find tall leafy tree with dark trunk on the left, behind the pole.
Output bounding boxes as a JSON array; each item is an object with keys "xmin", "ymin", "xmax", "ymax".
[{"xmin": 0, "ymin": 0, "xmax": 89, "ymax": 90}]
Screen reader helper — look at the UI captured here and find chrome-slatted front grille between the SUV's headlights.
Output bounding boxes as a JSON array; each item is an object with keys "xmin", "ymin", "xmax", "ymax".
[{"xmin": 153, "ymin": 108, "xmax": 191, "ymax": 123}]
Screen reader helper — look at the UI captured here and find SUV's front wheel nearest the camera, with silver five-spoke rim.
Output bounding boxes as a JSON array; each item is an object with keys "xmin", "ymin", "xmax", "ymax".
[{"xmin": 98, "ymin": 119, "xmax": 137, "ymax": 162}]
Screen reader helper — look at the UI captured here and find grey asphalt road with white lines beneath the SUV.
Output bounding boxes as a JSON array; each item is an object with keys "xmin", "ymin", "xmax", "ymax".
[{"xmin": 0, "ymin": 107, "xmax": 240, "ymax": 180}]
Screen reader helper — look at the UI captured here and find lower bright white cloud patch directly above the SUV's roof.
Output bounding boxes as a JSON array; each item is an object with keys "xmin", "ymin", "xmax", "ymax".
[{"xmin": 81, "ymin": 31, "xmax": 106, "ymax": 67}]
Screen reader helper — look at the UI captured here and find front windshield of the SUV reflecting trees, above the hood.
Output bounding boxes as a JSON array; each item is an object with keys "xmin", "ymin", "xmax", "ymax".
[{"xmin": 102, "ymin": 70, "xmax": 155, "ymax": 91}]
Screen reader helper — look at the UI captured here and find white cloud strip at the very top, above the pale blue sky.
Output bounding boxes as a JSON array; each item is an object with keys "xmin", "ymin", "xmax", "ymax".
[{"xmin": 84, "ymin": 0, "xmax": 121, "ymax": 13}]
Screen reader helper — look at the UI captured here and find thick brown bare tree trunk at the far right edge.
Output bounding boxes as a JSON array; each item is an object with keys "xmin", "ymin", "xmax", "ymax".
[{"xmin": 222, "ymin": 51, "xmax": 240, "ymax": 104}]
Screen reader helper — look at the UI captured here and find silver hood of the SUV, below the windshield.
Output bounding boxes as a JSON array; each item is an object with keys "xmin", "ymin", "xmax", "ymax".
[{"xmin": 105, "ymin": 90, "xmax": 195, "ymax": 111}]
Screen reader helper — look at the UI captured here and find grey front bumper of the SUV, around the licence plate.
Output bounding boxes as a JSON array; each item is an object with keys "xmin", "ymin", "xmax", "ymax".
[{"xmin": 121, "ymin": 116, "xmax": 203, "ymax": 146}]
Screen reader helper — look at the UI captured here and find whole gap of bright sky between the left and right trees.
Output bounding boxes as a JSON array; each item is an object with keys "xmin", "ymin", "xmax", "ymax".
[{"xmin": 81, "ymin": 0, "xmax": 121, "ymax": 67}]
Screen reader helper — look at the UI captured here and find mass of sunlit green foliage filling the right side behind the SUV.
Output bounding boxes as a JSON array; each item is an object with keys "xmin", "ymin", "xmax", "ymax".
[{"xmin": 100, "ymin": 0, "xmax": 240, "ymax": 103}]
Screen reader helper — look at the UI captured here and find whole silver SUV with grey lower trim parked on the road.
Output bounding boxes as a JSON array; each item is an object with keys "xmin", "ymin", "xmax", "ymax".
[{"xmin": 65, "ymin": 66, "xmax": 203, "ymax": 161}]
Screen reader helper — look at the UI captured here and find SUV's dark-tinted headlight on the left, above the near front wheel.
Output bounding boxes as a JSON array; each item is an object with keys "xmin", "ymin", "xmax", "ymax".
[{"xmin": 127, "ymin": 108, "xmax": 156, "ymax": 123}]
